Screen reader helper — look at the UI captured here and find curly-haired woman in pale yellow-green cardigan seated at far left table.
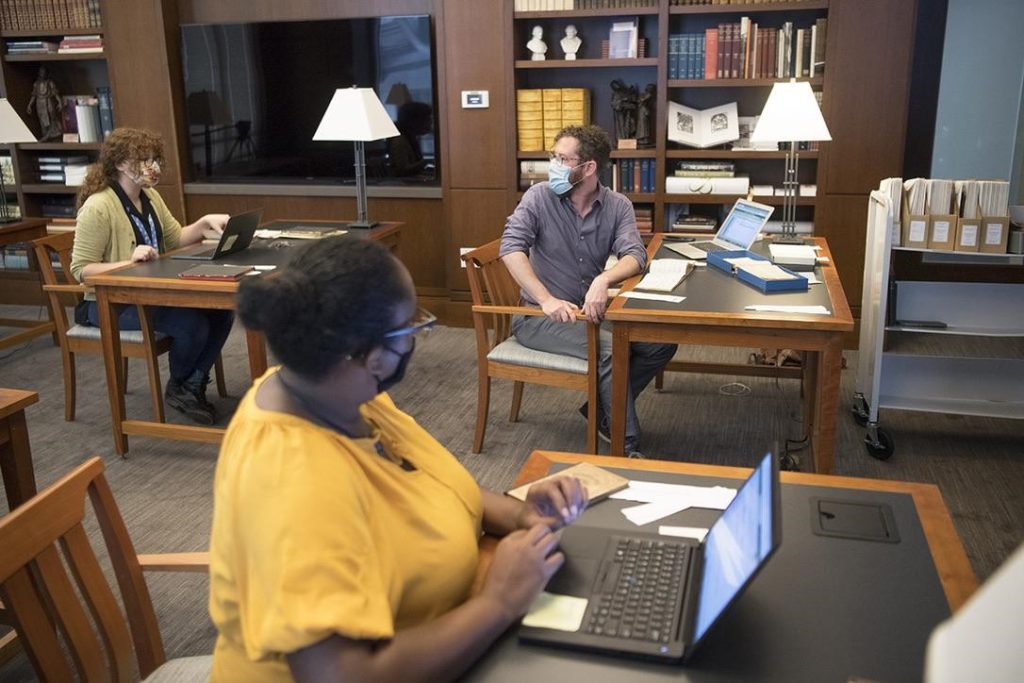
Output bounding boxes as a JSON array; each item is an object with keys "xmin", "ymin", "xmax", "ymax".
[{"xmin": 71, "ymin": 128, "xmax": 233, "ymax": 425}]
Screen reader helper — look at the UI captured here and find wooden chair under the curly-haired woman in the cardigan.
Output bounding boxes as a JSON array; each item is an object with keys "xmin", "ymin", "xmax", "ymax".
[{"xmin": 33, "ymin": 232, "xmax": 227, "ymax": 422}]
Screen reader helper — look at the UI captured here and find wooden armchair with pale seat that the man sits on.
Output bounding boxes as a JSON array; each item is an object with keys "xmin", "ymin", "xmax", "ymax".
[{"xmin": 462, "ymin": 240, "xmax": 599, "ymax": 453}]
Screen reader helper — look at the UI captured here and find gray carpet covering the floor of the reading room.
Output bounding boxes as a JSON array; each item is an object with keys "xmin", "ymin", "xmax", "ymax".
[{"xmin": 0, "ymin": 307, "xmax": 1024, "ymax": 681}]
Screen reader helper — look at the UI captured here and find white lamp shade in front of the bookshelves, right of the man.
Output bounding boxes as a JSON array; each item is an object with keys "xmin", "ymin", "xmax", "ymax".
[{"xmin": 751, "ymin": 80, "xmax": 831, "ymax": 142}]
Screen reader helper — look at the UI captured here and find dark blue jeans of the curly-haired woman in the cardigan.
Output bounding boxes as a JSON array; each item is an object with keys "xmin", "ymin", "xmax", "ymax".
[{"xmin": 88, "ymin": 301, "xmax": 234, "ymax": 382}]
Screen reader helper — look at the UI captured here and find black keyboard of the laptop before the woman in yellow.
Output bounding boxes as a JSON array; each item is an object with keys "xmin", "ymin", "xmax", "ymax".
[{"xmin": 583, "ymin": 537, "xmax": 692, "ymax": 643}]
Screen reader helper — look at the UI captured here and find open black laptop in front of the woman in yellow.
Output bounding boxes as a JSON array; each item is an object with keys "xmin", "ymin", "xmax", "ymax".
[{"xmin": 519, "ymin": 454, "xmax": 781, "ymax": 661}]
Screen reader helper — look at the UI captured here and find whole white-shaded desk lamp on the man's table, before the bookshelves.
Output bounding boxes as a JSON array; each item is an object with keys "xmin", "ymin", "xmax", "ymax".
[{"xmin": 751, "ymin": 79, "xmax": 831, "ymax": 243}]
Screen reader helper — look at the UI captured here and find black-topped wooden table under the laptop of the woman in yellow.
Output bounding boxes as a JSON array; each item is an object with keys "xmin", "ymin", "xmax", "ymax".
[{"xmin": 464, "ymin": 451, "xmax": 978, "ymax": 683}]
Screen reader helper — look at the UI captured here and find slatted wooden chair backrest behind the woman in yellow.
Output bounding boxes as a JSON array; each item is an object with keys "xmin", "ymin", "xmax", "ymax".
[{"xmin": 0, "ymin": 458, "xmax": 166, "ymax": 681}]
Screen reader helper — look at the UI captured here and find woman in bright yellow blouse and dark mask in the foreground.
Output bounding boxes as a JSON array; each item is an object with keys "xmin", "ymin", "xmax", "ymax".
[{"xmin": 210, "ymin": 237, "xmax": 586, "ymax": 683}]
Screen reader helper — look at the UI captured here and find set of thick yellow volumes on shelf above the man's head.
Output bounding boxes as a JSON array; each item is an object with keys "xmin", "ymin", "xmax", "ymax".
[{"xmin": 515, "ymin": 88, "xmax": 590, "ymax": 152}]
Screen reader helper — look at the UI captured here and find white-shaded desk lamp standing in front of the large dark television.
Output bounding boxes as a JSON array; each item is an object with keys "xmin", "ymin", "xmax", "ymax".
[{"xmin": 313, "ymin": 85, "xmax": 398, "ymax": 227}]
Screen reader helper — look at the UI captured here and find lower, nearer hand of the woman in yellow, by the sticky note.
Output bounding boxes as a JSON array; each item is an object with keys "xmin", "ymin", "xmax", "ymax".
[{"xmin": 481, "ymin": 524, "xmax": 565, "ymax": 620}]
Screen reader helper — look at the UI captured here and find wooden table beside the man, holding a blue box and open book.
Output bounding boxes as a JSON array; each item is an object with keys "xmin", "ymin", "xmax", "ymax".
[{"xmin": 606, "ymin": 234, "xmax": 853, "ymax": 474}]
